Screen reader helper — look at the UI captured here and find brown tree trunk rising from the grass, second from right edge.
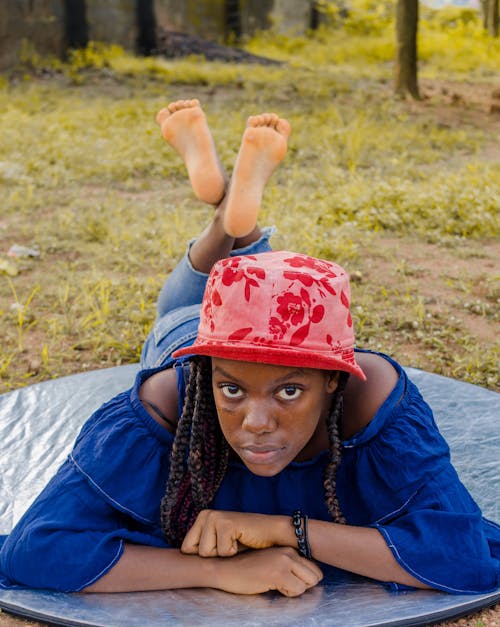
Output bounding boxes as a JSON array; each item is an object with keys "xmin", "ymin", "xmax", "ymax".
[{"xmin": 394, "ymin": 0, "xmax": 420, "ymax": 100}]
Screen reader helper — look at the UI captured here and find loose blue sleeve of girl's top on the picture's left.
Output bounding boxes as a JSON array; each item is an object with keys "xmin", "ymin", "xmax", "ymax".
[{"xmin": 0, "ymin": 461, "xmax": 128, "ymax": 592}]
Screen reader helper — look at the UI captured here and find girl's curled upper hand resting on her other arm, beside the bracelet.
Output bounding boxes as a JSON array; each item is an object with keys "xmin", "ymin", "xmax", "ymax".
[{"xmin": 181, "ymin": 509, "xmax": 295, "ymax": 557}]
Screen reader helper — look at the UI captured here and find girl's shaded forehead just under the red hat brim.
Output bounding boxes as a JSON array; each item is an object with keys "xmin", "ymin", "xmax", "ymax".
[{"xmin": 212, "ymin": 357, "xmax": 325, "ymax": 383}]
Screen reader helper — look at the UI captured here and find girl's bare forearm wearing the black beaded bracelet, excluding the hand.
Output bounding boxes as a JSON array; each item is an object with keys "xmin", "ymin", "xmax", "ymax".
[{"xmin": 281, "ymin": 519, "xmax": 428, "ymax": 588}]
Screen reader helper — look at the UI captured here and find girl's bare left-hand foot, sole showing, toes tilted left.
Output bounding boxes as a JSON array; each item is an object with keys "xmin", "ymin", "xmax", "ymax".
[{"xmin": 156, "ymin": 99, "xmax": 226, "ymax": 205}]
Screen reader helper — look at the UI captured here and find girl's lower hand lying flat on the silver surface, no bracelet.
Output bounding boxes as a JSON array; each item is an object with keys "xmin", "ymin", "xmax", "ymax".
[{"xmin": 213, "ymin": 547, "xmax": 323, "ymax": 597}]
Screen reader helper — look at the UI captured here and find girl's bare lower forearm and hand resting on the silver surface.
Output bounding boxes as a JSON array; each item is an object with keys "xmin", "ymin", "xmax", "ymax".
[{"xmin": 83, "ymin": 544, "xmax": 323, "ymax": 597}]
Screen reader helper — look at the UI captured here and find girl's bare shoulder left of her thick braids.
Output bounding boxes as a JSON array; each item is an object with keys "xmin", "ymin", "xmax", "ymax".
[{"xmin": 139, "ymin": 368, "xmax": 178, "ymax": 433}]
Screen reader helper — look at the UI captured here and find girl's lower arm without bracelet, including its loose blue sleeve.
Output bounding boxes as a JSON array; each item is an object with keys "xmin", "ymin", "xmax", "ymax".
[{"xmin": 0, "ymin": 462, "xmax": 322, "ymax": 596}]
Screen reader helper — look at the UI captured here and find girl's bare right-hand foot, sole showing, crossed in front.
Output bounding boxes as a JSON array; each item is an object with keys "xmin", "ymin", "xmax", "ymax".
[{"xmin": 224, "ymin": 113, "xmax": 290, "ymax": 237}]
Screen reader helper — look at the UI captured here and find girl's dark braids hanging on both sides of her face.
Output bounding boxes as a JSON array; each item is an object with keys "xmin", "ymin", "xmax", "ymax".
[{"xmin": 161, "ymin": 357, "xmax": 349, "ymax": 547}]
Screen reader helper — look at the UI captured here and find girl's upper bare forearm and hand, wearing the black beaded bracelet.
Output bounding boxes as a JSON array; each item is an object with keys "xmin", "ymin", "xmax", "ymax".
[{"xmin": 181, "ymin": 510, "xmax": 427, "ymax": 588}]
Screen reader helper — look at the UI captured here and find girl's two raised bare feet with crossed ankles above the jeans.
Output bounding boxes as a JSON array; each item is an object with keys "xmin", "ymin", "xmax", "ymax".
[{"xmin": 156, "ymin": 100, "xmax": 290, "ymax": 273}]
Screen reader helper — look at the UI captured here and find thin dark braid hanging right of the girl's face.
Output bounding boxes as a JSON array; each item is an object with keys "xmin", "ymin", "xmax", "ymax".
[{"xmin": 323, "ymin": 372, "xmax": 349, "ymax": 524}]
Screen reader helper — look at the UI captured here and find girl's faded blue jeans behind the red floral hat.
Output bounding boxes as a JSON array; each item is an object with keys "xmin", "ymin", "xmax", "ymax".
[{"xmin": 141, "ymin": 227, "xmax": 276, "ymax": 368}]
